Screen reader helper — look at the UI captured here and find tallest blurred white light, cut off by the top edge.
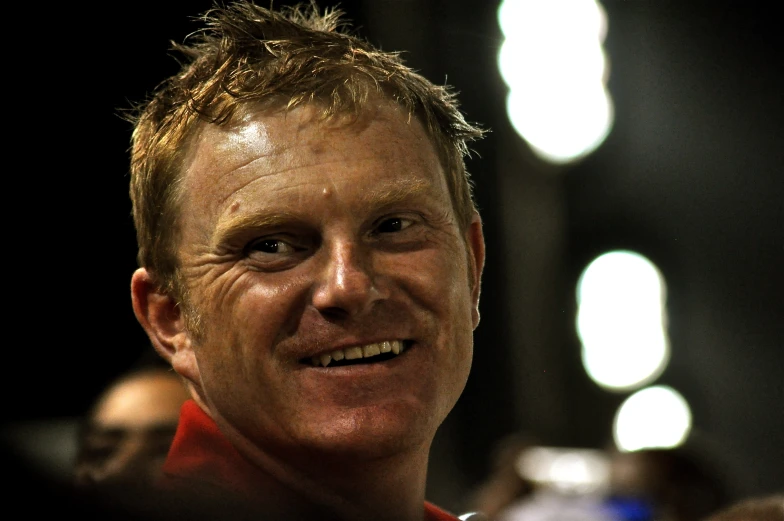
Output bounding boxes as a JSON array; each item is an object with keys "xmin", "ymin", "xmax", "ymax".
[{"xmin": 498, "ymin": 0, "xmax": 614, "ymax": 163}]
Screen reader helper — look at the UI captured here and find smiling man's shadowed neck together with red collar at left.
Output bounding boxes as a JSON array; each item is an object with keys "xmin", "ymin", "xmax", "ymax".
[{"xmin": 170, "ymin": 402, "xmax": 432, "ymax": 521}]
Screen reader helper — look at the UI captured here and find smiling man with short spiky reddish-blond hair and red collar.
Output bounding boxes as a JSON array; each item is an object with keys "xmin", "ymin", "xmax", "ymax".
[{"xmin": 130, "ymin": 2, "xmax": 484, "ymax": 521}]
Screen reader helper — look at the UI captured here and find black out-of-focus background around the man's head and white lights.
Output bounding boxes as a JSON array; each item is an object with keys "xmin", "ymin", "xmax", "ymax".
[{"xmin": 2, "ymin": 0, "xmax": 784, "ymax": 508}]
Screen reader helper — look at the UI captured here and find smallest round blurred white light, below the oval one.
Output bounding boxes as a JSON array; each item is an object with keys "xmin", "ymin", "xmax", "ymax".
[{"xmin": 613, "ymin": 385, "xmax": 691, "ymax": 452}]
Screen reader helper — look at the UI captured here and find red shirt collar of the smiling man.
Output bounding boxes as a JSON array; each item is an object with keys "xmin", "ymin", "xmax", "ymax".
[{"xmin": 161, "ymin": 400, "xmax": 458, "ymax": 521}]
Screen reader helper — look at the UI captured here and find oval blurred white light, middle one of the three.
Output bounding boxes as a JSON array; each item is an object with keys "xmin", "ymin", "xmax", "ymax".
[{"xmin": 576, "ymin": 251, "xmax": 670, "ymax": 391}]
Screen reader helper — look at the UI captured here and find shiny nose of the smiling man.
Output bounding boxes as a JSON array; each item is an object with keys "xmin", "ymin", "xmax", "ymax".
[{"xmin": 313, "ymin": 241, "xmax": 388, "ymax": 317}]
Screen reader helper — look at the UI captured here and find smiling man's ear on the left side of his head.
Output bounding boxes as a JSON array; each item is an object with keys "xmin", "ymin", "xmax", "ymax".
[{"xmin": 131, "ymin": 268, "xmax": 200, "ymax": 382}]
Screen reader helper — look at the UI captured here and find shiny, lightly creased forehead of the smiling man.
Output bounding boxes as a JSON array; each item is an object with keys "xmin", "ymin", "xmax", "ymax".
[{"xmin": 179, "ymin": 101, "xmax": 448, "ymax": 216}]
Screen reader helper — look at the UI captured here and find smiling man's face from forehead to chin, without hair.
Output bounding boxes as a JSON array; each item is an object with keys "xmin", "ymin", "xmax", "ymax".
[{"xmin": 175, "ymin": 99, "xmax": 484, "ymax": 462}]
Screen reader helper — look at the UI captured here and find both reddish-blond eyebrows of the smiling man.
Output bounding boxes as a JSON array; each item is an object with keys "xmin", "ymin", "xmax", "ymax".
[{"xmin": 212, "ymin": 179, "xmax": 432, "ymax": 247}]
